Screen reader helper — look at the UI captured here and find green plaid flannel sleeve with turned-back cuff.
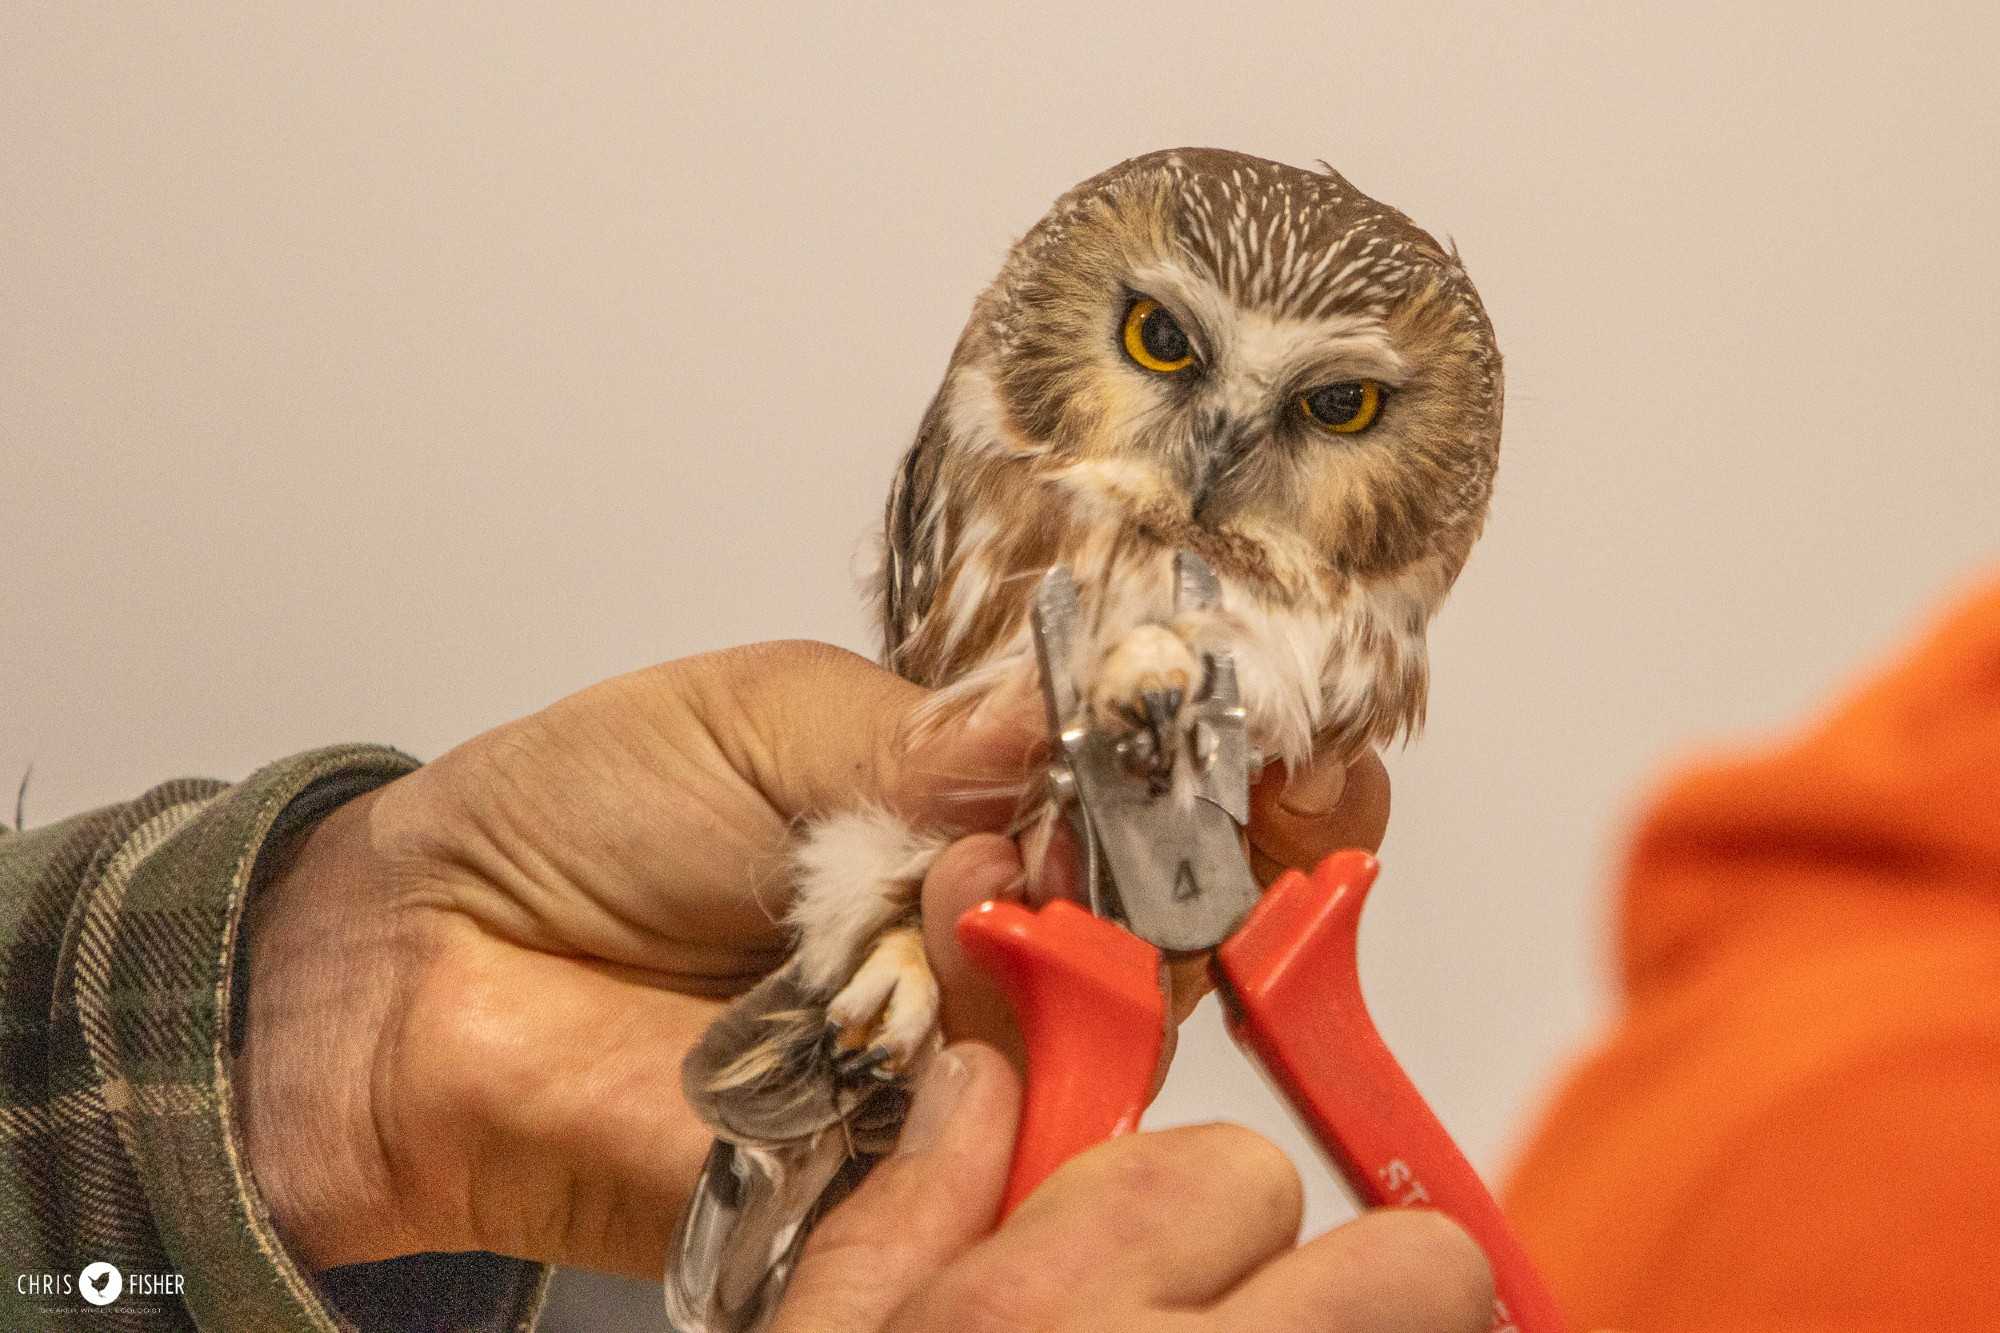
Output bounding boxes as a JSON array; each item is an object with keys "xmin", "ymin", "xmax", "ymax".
[{"xmin": 0, "ymin": 747, "xmax": 546, "ymax": 1333}]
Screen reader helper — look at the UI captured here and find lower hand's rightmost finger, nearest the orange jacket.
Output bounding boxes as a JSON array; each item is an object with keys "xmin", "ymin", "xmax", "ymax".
[{"xmin": 1216, "ymin": 1209, "xmax": 1494, "ymax": 1333}]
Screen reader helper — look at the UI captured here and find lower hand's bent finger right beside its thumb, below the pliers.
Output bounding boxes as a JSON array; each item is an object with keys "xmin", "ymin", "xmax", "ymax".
[{"xmin": 892, "ymin": 1125, "xmax": 1300, "ymax": 1329}]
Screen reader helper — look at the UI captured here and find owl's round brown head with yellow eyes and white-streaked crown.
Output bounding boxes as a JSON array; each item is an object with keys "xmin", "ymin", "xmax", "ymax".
[{"xmin": 940, "ymin": 148, "xmax": 1502, "ymax": 594}]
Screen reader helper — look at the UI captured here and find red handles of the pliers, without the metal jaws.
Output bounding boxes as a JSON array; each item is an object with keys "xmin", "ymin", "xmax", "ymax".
[{"xmin": 958, "ymin": 851, "xmax": 1566, "ymax": 1333}]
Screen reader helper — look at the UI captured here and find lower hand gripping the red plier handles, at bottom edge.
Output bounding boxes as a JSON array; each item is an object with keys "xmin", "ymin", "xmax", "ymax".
[{"xmin": 772, "ymin": 1043, "xmax": 1492, "ymax": 1333}]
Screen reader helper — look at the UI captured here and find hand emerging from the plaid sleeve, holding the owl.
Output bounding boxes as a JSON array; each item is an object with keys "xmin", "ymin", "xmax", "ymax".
[{"xmin": 236, "ymin": 644, "xmax": 1386, "ymax": 1277}]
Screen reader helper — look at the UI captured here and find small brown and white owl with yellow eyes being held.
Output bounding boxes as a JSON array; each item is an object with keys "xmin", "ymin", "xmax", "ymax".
[{"xmin": 668, "ymin": 148, "xmax": 1502, "ymax": 1333}]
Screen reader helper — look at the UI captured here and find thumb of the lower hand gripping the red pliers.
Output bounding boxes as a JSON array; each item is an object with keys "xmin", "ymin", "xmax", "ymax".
[{"xmin": 772, "ymin": 1041, "xmax": 1020, "ymax": 1333}]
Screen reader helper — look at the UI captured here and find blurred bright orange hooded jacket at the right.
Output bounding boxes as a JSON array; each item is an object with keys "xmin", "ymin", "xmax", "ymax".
[{"xmin": 1504, "ymin": 584, "xmax": 2000, "ymax": 1333}]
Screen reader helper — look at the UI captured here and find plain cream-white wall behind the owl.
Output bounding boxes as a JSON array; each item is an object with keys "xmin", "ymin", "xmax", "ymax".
[{"xmin": 0, "ymin": 0, "xmax": 2000, "ymax": 1327}]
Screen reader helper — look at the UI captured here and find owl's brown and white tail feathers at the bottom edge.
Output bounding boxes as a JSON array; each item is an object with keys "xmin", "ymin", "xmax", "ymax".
[{"xmin": 666, "ymin": 1125, "xmax": 850, "ymax": 1333}]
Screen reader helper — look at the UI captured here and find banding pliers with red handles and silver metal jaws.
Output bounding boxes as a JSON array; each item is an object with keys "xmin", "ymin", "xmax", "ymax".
[{"xmin": 958, "ymin": 552, "xmax": 1566, "ymax": 1333}]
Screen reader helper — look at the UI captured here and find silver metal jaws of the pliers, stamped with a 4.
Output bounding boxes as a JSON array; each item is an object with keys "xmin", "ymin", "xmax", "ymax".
[{"xmin": 1034, "ymin": 550, "xmax": 1258, "ymax": 953}]
